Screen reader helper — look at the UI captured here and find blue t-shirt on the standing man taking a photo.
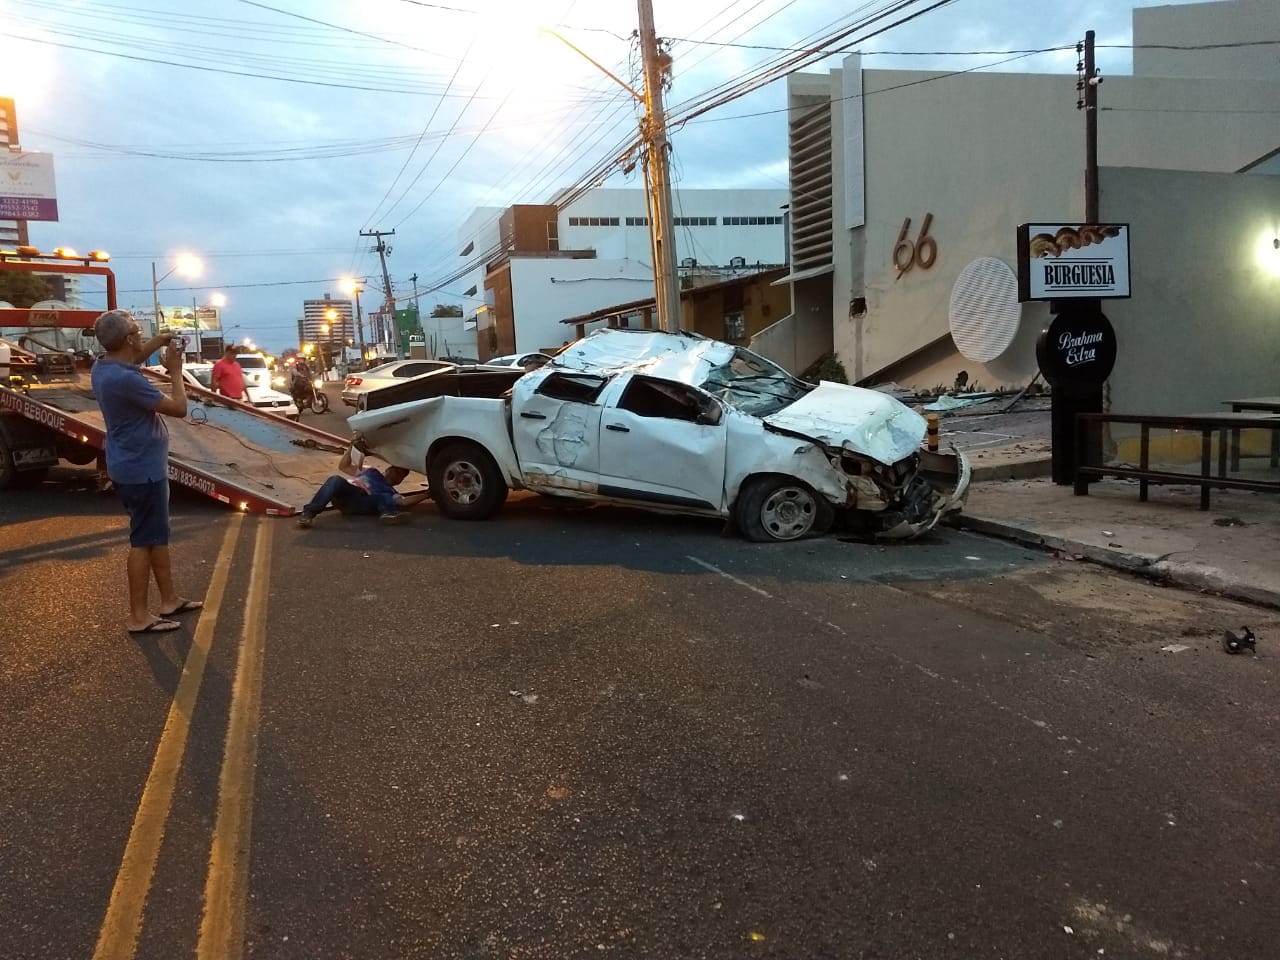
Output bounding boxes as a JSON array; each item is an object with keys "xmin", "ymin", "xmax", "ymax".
[{"xmin": 90, "ymin": 357, "xmax": 169, "ymax": 484}]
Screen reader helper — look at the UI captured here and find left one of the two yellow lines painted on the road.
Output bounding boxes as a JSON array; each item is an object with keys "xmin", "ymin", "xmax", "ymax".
[{"xmin": 93, "ymin": 513, "xmax": 244, "ymax": 960}]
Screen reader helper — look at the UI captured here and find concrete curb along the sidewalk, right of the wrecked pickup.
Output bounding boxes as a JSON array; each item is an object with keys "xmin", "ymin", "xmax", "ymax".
[{"xmin": 951, "ymin": 512, "xmax": 1280, "ymax": 609}]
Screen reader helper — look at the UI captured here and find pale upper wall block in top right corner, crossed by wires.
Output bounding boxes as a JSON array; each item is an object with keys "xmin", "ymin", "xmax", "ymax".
[{"xmin": 1133, "ymin": 0, "xmax": 1280, "ymax": 79}]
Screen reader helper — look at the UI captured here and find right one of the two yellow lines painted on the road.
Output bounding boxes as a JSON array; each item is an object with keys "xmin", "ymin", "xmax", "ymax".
[{"xmin": 196, "ymin": 520, "xmax": 274, "ymax": 960}]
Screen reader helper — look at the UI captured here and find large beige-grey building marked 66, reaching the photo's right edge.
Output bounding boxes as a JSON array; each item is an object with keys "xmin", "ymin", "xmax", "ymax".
[{"xmin": 773, "ymin": 0, "xmax": 1280, "ymax": 412}]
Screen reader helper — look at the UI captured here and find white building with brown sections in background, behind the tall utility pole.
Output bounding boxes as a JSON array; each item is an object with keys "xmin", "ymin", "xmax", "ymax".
[{"xmin": 450, "ymin": 189, "xmax": 787, "ymax": 360}]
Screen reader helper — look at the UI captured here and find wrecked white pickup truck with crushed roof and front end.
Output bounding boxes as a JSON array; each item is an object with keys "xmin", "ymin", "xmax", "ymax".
[{"xmin": 348, "ymin": 330, "xmax": 970, "ymax": 541}]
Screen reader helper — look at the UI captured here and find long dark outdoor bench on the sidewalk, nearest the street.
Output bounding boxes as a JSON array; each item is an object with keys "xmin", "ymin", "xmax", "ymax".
[{"xmin": 1075, "ymin": 412, "xmax": 1280, "ymax": 509}]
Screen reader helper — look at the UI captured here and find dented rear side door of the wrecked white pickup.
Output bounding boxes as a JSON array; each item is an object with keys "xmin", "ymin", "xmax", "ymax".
[{"xmin": 511, "ymin": 370, "xmax": 608, "ymax": 493}]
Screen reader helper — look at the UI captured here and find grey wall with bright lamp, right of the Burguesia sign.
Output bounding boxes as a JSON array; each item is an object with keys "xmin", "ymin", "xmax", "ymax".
[{"xmin": 1101, "ymin": 169, "xmax": 1280, "ymax": 413}]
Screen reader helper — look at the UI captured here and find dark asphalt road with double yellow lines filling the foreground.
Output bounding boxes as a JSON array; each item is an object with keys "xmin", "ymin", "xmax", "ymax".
[{"xmin": 0, "ymin": 463, "xmax": 1280, "ymax": 960}]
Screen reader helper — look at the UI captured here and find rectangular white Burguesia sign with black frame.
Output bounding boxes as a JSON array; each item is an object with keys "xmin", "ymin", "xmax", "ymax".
[{"xmin": 1018, "ymin": 223, "xmax": 1129, "ymax": 302}]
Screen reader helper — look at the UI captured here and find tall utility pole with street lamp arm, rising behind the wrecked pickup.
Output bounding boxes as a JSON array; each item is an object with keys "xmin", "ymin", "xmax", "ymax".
[{"xmin": 637, "ymin": 0, "xmax": 681, "ymax": 333}]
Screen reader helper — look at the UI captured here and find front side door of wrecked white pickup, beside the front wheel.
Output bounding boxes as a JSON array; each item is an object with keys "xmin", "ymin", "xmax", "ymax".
[{"xmin": 600, "ymin": 374, "xmax": 727, "ymax": 511}]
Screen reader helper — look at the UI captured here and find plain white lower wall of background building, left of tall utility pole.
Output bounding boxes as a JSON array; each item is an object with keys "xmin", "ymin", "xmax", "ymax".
[{"xmin": 511, "ymin": 257, "xmax": 653, "ymax": 352}]
